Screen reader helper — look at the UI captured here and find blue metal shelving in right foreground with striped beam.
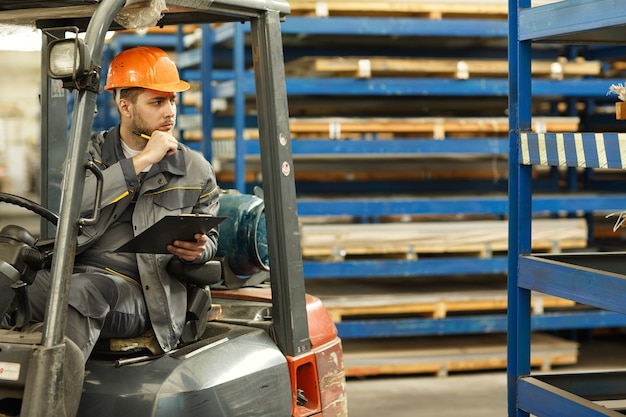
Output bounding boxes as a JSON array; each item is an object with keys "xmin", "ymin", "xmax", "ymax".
[{"xmin": 507, "ymin": 0, "xmax": 626, "ymax": 417}]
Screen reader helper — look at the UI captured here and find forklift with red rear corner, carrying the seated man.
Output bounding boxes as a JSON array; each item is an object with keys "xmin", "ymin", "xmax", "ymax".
[{"xmin": 0, "ymin": 0, "xmax": 347, "ymax": 417}]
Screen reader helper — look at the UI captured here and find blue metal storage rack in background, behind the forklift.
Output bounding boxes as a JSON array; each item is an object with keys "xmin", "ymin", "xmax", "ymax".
[{"xmin": 190, "ymin": 17, "xmax": 626, "ymax": 338}]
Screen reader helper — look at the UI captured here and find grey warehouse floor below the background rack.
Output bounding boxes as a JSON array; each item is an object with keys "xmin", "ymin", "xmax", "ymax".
[{"xmin": 347, "ymin": 335, "xmax": 626, "ymax": 417}]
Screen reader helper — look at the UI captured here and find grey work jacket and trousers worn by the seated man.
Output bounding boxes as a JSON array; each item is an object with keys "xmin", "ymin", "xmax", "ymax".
[{"xmin": 29, "ymin": 126, "xmax": 219, "ymax": 359}]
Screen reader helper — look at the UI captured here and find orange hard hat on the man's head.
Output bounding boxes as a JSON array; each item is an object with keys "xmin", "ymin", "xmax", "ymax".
[{"xmin": 104, "ymin": 46, "xmax": 189, "ymax": 93}]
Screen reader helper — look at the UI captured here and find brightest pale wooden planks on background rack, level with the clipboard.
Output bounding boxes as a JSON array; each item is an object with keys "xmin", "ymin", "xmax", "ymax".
[{"xmin": 300, "ymin": 219, "xmax": 587, "ymax": 258}]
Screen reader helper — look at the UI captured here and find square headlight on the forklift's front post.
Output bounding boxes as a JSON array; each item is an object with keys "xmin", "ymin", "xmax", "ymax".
[{"xmin": 48, "ymin": 38, "xmax": 89, "ymax": 79}]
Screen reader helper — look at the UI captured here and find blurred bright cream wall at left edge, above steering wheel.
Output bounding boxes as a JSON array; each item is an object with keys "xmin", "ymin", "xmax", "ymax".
[{"xmin": 0, "ymin": 51, "xmax": 41, "ymax": 195}]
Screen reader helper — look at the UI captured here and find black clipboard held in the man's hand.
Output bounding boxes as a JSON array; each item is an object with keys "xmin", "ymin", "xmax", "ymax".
[{"xmin": 115, "ymin": 214, "xmax": 226, "ymax": 253}]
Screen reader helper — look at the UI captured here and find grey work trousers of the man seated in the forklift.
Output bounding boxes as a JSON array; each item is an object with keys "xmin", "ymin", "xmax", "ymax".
[{"xmin": 28, "ymin": 266, "xmax": 150, "ymax": 361}]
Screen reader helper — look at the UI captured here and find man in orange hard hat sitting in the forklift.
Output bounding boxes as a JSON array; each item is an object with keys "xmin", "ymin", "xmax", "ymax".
[{"xmin": 29, "ymin": 47, "xmax": 219, "ymax": 361}]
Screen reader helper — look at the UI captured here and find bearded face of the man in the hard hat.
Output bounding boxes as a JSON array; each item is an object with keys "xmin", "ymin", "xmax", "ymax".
[{"xmin": 130, "ymin": 90, "xmax": 176, "ymax": 135}]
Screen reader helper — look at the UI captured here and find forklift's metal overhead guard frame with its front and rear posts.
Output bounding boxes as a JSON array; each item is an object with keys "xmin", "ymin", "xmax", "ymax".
[{"xmin": 0, "ymin": 0, "xmax": 320, "ymax": 415}]
